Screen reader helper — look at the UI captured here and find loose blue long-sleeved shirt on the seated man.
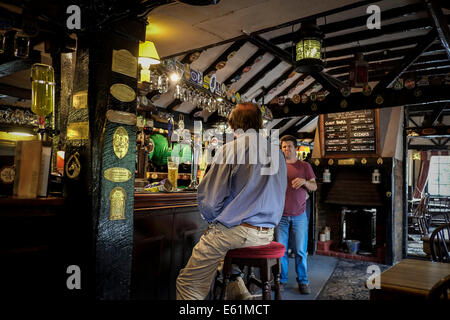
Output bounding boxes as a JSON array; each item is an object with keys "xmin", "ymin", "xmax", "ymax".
[{"xmin": 198, "ymin": 133, "xmax": 287, "ymax": 228}]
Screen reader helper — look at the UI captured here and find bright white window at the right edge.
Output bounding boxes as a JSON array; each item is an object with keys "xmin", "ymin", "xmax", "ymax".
[{"xmin": 428, "ymin": 156, "xmax": 450, "ymax": 196}]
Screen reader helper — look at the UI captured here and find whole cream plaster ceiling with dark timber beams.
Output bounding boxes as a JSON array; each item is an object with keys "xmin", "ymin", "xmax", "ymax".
[{"xmin": 0, "ymin": 0, "xmax": 450, "ymax": 144}]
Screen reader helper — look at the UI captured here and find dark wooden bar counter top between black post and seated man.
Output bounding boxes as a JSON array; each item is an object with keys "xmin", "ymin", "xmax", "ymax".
[{"xmin": 134, "ymin": 192, "xmax": 197, "ymax": 212}]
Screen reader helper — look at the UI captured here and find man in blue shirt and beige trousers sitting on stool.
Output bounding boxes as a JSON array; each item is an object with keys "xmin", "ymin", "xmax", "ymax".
[{"xmin": 177, "ymin": 103, "xmax": 287, "ymax": 300}]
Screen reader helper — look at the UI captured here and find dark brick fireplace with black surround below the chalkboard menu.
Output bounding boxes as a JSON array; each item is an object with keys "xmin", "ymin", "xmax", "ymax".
[{"xmin": 314, "ymin": 162, "xmax": 392, "ymax": 264}]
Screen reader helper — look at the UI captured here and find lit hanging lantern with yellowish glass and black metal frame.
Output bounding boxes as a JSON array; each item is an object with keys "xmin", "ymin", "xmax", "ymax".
[{"xmin": 295, "ymin": 21, "xmax": 325, "ymax": 73}]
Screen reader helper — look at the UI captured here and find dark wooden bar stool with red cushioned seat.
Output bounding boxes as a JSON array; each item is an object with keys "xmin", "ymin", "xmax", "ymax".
[{"xmin": 220, "ymin": 241, "xmax": 286, "ymax": 300}]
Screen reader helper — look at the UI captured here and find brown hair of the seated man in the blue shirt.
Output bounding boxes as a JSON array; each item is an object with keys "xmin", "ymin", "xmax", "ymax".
[{"xmin": 228, "ymin": 102, "xmax": 263, "ymax": 131}]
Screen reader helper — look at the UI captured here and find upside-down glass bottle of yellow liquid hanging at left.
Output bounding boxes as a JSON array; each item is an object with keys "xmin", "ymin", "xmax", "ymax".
[{"xmin": 31, "ymin": 63, "xmax": 55, "ymax": 129}]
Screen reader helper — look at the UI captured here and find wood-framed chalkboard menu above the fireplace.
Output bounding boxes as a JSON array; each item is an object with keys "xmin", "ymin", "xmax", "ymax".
[{"xmin": 321, "ymin": 110, "xmax": 378, "ymax": 155}]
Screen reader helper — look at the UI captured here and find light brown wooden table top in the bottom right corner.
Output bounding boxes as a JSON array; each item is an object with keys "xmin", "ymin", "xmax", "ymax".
[{"xmin": 381, "ymin": 259, "xmax": 450, "ymax": 297}]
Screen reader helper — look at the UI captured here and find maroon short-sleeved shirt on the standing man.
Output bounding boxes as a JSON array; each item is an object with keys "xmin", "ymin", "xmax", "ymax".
[{"xmin": 283, "ymin": 160, "xmax": 316, "ymax": 216}]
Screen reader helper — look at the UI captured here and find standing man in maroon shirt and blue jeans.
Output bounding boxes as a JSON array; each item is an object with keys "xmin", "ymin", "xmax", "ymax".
[{"xmin": 277, "ymin": 135, "xmax": 317, "ymax": 294}]
